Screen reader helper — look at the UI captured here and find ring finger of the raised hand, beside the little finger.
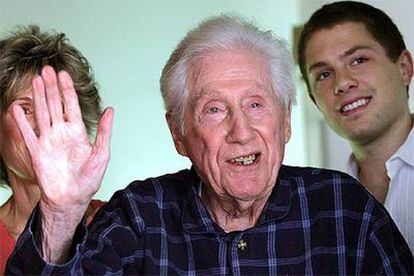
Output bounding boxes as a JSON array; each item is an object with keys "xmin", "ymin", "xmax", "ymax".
[{"xmin": 32, "ymin": 76, "xmax": 50, "ymax": 134}]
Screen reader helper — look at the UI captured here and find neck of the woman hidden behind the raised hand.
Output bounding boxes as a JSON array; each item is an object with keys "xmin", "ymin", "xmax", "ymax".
[{"xmin": 0, "ymin": 172, "xmax": 40, "ymax": 239}]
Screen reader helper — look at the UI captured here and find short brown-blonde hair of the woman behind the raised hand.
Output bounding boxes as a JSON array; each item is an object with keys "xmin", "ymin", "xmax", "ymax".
[{"xmin": 0, "ymin": 25, "xmax": 101, "ymax": 184}]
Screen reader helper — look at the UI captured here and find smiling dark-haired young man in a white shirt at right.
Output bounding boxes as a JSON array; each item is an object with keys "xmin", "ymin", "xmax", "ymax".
[{"xmin": 298, "ymin": 1, "xmax": 414, "ymax": 251}]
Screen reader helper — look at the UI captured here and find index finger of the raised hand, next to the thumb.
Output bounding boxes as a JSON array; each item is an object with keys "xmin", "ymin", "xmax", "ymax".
[{"xmin": 58, "ymin": 71, "xmax": 82, "ymax": 122}]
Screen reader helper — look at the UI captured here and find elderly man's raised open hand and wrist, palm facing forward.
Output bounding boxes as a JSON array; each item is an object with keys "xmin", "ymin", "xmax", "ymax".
[{"xmin": 13, "ymin": 66, "xmax": 113, "ymax": 261}]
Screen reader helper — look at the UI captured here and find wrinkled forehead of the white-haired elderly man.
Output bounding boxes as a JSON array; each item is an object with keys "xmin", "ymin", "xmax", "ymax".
[{"xmin": 190, "ymin": 49, "xmax": 270, "ymax": 96}]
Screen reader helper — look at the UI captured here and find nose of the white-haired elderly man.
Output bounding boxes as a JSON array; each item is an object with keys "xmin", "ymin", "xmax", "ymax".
[{"xmin": 226, "ymin": 111, "xmax": 254, "ymax": 145}]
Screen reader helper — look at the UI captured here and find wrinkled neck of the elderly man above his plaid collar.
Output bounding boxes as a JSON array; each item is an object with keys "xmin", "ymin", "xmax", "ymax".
[{"xmin": 201, "ymin": 187, "xmax": 271, "ymax": 233}]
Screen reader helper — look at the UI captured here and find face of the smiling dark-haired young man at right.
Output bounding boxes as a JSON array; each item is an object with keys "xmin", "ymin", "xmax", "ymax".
[{"xmin": 305, "ymin": 22, "xmax": 412, "ymax": 144}]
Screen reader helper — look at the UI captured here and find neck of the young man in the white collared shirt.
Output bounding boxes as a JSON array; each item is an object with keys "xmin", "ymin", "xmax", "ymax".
[{"xmin": 351, "ymin": 113, "xmax": 413, "ymax": 203}]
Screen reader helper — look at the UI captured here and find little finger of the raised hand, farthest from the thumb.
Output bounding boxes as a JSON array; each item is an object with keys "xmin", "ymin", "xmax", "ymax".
[{"xmin": 12, "ymin": 104, "xmax": 37, "ymax": 155}]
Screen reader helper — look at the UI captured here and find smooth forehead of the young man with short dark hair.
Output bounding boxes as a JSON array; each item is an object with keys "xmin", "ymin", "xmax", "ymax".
[{"xmin": 305, "ymin": 22, "xmax": 385, "ymax": 66}]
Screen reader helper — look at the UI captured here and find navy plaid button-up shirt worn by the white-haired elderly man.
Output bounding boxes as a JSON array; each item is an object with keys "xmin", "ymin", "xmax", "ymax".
[{"xmin": 6, "ymin": 166, "xmax": 414, "ymax": 275}]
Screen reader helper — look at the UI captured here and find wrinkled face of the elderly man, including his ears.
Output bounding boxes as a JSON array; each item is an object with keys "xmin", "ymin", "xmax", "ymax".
[{"xmin": 168, "ymin": 50, "xmax": 290, "ymax": 202}]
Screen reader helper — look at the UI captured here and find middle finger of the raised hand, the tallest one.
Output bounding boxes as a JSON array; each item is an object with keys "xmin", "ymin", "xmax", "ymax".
[{"xmin": 42, "ymin": 66, "xmax": 63, "ymax": 125}]
